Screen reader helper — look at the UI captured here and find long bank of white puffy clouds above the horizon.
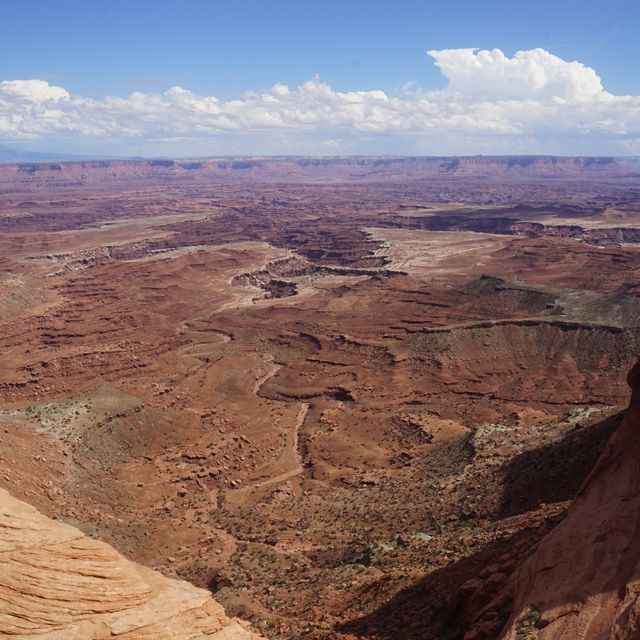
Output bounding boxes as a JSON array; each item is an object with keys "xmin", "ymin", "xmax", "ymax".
[{"xmin": 0, "ymin": 49, "xmax": 640, "ymax": 155}]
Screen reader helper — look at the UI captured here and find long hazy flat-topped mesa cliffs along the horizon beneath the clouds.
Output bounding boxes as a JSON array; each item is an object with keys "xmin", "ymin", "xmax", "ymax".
[{"xmin": 0, "ymin": 156, "xmax": 640, "ymax": 184}]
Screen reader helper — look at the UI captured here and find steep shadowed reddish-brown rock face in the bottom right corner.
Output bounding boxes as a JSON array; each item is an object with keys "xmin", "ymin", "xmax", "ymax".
[{"xmin": 465, "ymin": 362, "xmax": 640, "ymax": 640}]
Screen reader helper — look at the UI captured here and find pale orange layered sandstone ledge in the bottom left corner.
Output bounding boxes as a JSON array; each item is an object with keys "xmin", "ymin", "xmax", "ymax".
[{"xmin": 0, "ymin": 489, "xmax": 258, "ymax": 640}]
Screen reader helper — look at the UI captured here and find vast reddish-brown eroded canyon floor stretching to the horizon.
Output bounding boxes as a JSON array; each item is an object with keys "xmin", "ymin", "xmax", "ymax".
[{"xmin": 0, "ymin": 158, "xmax": 640, "ymax": 640}]
